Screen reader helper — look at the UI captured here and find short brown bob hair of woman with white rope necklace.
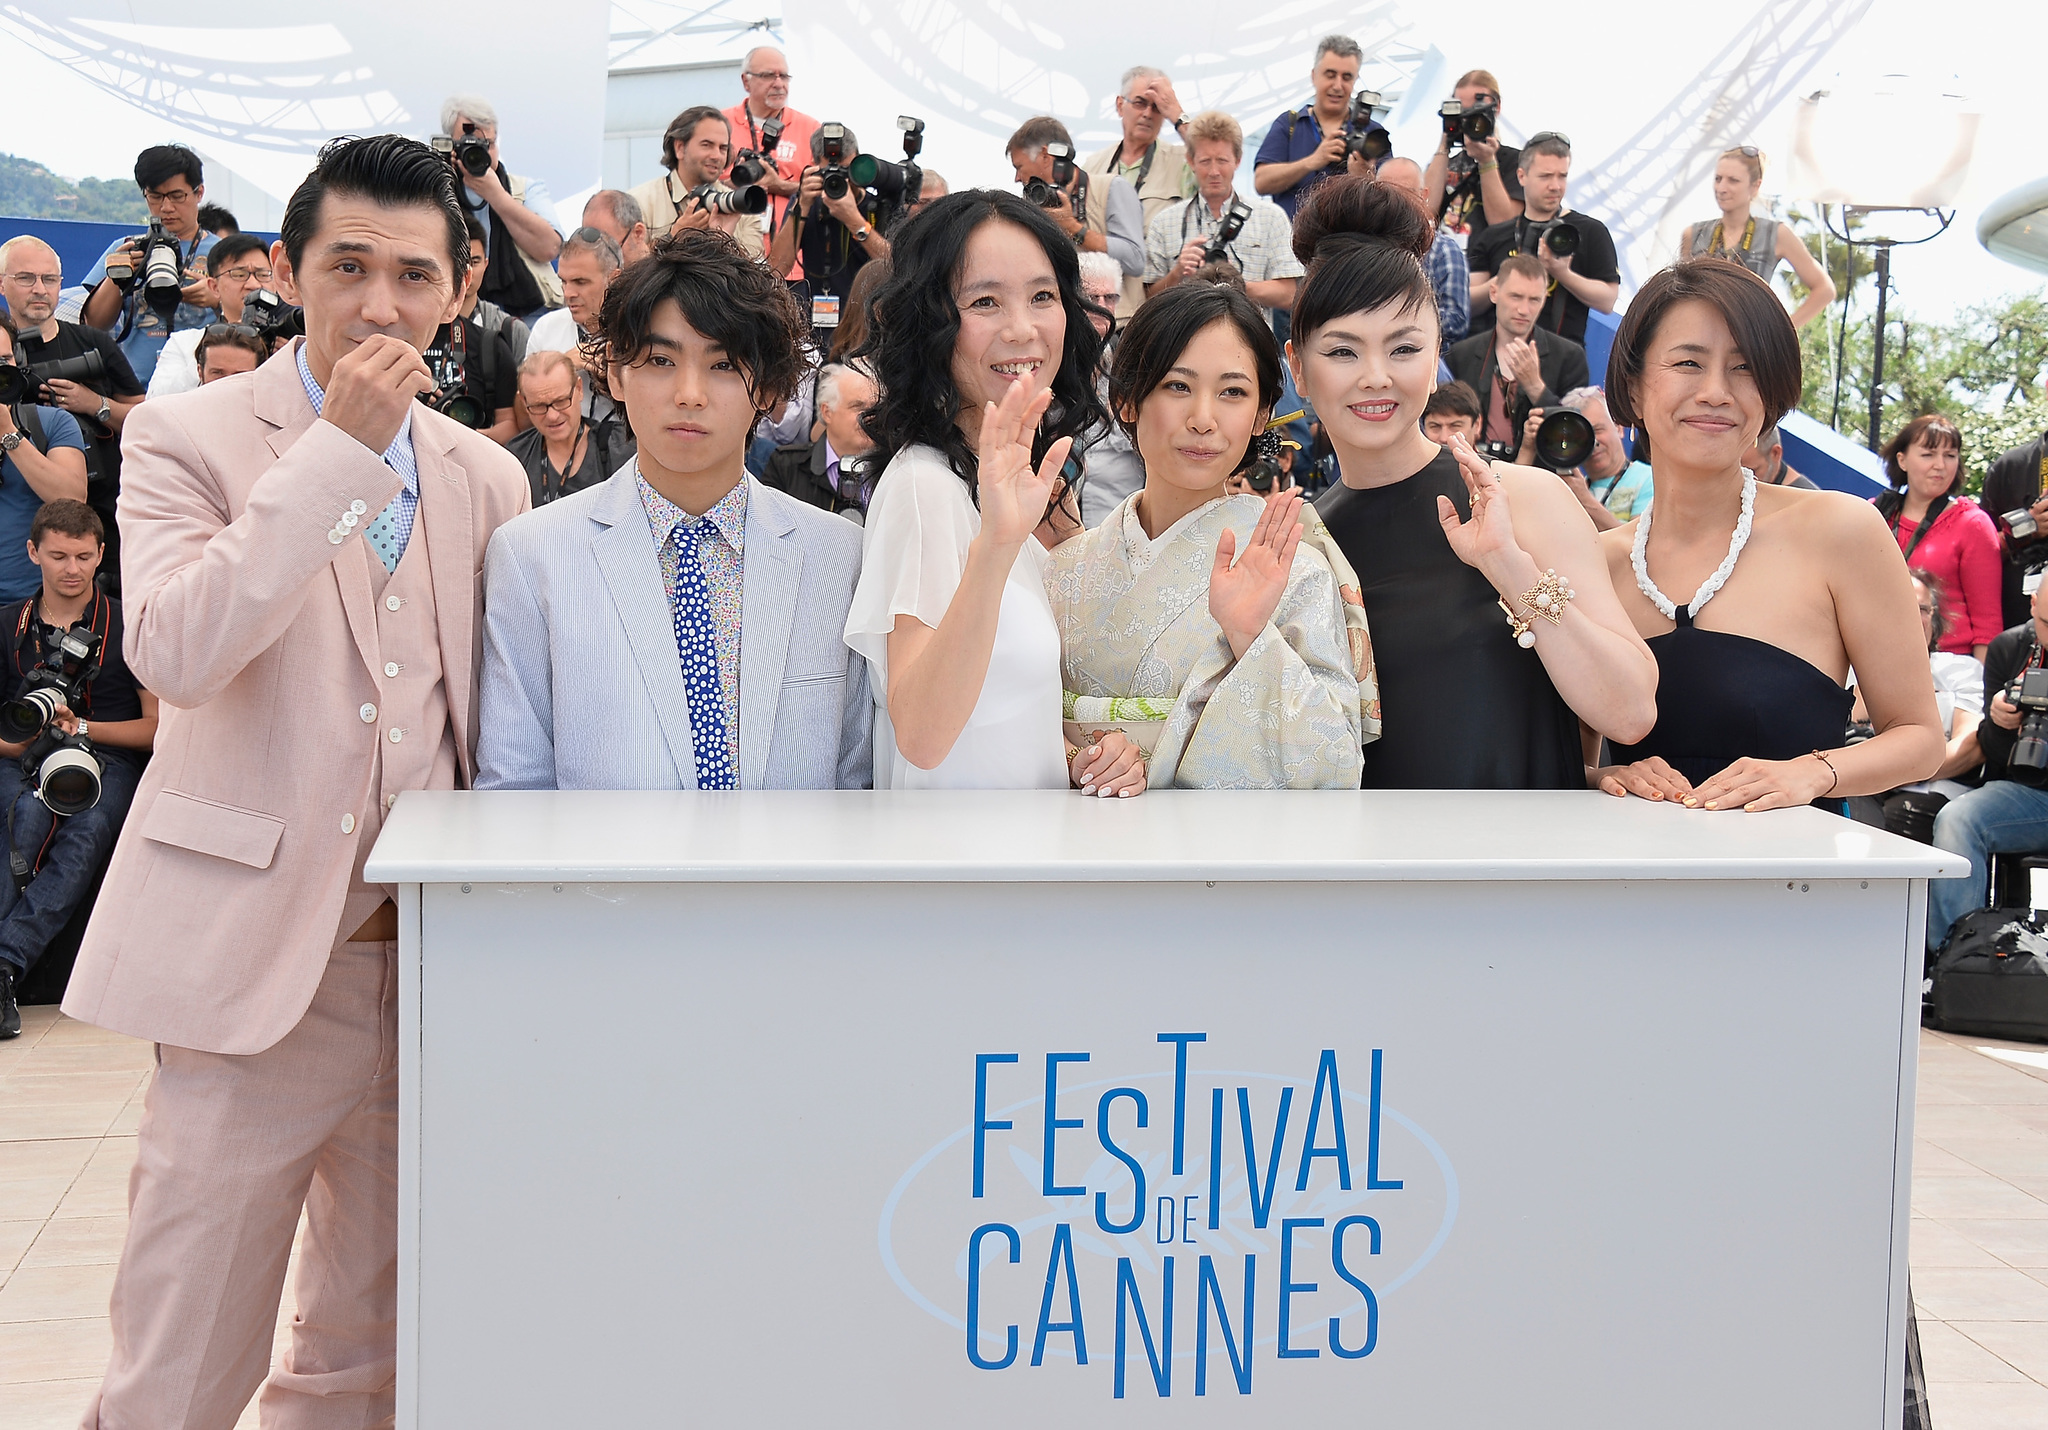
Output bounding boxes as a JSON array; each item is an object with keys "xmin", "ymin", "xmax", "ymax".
[{"xmin": 1606, "ymin": 258, "xmax": 1800, "ymax": 430}]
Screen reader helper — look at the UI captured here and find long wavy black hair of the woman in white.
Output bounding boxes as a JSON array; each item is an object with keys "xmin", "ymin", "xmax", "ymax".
[{"xmin": 850, "ymin": 188, "xmax": 1110, "ymax": 504}]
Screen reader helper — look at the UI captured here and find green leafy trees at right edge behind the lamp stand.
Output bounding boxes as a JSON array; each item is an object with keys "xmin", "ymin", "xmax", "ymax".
[{"xmin": 1782, "ymin": 198, "xmax": 2048, "ymax": 492}]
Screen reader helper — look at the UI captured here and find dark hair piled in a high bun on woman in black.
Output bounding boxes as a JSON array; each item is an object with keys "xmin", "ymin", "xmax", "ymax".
[{"xmin": 1294, "ymin": 174, "xmax": 1442, "ymax": 342}]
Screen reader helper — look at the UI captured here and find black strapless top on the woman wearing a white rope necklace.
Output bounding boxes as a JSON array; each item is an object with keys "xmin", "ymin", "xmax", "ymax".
[{"xmin": 1614, "ymin": 606, "xmax": 1855, "ymax": 785}]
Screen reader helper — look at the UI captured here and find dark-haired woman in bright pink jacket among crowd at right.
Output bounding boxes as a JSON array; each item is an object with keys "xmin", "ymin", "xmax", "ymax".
[{"xmin": 1878, "ymin": 412, "xmax": 2003, "ymax": 660}]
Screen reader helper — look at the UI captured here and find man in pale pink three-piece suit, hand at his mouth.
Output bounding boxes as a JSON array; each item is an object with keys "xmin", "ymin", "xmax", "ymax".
[{"xmin": 66, "ymin": 135, "xmax": 528, "ymax": 1430}]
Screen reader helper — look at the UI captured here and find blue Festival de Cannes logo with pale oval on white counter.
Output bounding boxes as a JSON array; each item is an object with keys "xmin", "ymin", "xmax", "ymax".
[{"xmin": 879, "ymin": 1033, "xmax": 1458, "ymax": 1399}]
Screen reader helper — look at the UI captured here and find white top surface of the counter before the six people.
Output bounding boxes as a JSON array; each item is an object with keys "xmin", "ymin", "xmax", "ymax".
[{"xmin": 367, "ymin": 791, "xmax": 1970, "ymax": 883}]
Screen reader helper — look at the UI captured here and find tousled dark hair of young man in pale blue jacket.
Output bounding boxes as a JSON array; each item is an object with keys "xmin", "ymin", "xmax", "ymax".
[{"xmin": 584, "ymin": 229, "xmax": 809, "ymax": 412}]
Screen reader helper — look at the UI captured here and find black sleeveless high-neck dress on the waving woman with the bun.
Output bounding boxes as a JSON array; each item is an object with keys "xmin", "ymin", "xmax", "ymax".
[{"xmin": 1315, "ymin": 451, "xmax": 1581, "ymax": 789}]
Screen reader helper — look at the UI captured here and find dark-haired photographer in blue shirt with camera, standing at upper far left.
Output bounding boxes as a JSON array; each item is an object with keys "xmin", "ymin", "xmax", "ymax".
[{"xmin": 80, "ymin": 143, "xmax": 217, "ymax": 383}]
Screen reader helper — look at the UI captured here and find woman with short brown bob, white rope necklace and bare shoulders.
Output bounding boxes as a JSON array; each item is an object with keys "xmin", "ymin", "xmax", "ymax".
[{"xmin": 1595, "ymin": 258, "xmax": 1946, "ymax": 809}]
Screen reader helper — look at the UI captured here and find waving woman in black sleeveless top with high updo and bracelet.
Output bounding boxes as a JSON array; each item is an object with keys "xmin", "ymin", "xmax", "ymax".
[{"xmin": 1288, "ymin": 176, "xmax": 1657, "ymax": 789}]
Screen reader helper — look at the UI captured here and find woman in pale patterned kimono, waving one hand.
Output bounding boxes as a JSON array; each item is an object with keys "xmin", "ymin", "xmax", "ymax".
[{"xmin": 1047, "ymin": 285, "xmax": 1376, "ymax": 789}]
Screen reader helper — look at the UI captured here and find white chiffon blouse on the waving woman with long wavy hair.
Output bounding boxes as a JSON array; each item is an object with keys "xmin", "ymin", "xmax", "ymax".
[{"xmin": 846, "ymin": 447, "xmax": 1067, "ymax": 789}]
